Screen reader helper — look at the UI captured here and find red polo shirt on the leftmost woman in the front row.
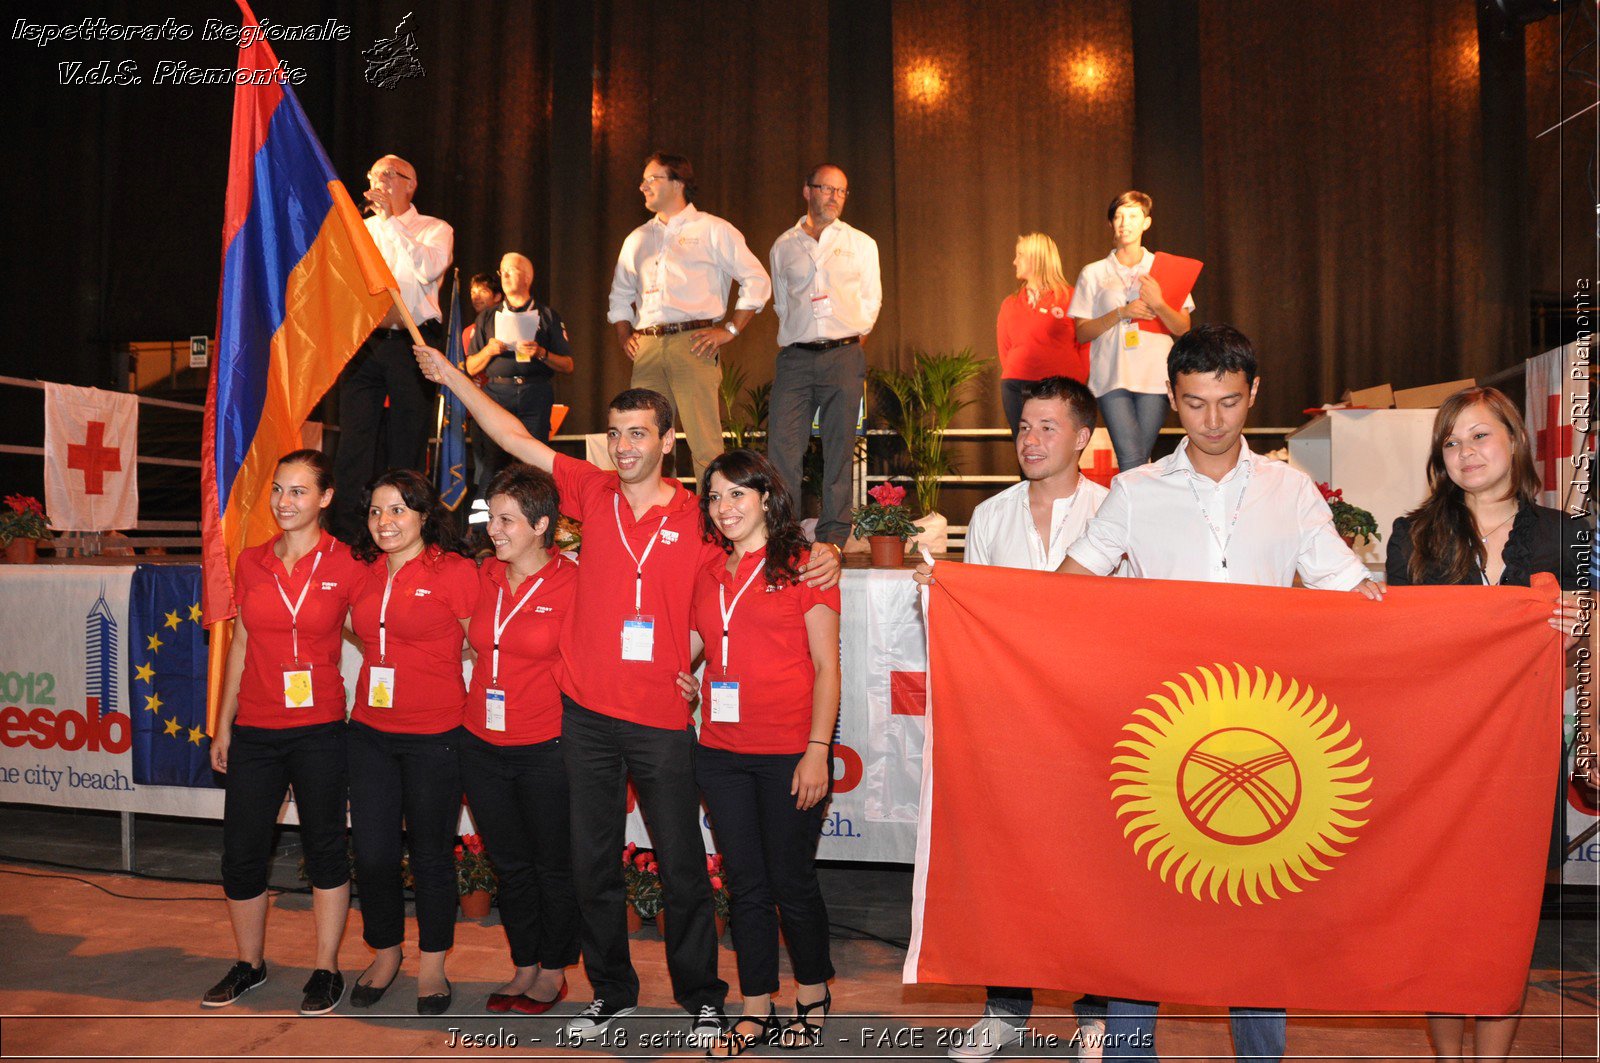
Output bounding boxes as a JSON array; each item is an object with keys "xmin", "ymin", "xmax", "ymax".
[{"xmin": 234, "ymin": 532, "xmax": 368, "ymax": 727}]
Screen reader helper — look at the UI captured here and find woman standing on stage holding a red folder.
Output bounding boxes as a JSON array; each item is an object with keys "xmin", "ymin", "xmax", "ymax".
[{"xmin": 1067, "ymin": 191, "xmax": 1195, "ymax": 471}]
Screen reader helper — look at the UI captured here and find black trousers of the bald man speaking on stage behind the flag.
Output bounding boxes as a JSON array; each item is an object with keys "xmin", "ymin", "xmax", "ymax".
[{"xmin": 333, "ymin": 320, "xmax": 445, "ymax": 543}]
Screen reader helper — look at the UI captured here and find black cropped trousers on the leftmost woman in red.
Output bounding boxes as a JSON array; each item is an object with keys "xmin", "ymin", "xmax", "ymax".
[{"xmin": 222, "ymin": 722, "xmax": 350, "ymax": 901}]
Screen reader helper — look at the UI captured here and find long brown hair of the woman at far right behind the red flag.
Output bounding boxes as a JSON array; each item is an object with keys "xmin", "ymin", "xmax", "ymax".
[{"xmin": 1408, "ymin": 387, "xmax": 1539, "ymax": 583}]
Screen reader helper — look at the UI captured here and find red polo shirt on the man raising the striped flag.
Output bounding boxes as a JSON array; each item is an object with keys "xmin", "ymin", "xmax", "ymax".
[{"xmin": 552, "ymin": 455, "xmax": 722, "ymax": 730}]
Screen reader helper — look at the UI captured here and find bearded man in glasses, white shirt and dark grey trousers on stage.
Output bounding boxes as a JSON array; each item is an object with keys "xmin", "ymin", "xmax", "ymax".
[{"xmin": 766, "ymin": 163, "xmax": 883, "ymax": 544}]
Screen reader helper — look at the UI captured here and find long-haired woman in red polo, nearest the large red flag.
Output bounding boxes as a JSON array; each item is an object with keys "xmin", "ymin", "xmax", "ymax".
[{"xmin": 678, "ymin": 450, "xmax": 840, "ymax": 1057}]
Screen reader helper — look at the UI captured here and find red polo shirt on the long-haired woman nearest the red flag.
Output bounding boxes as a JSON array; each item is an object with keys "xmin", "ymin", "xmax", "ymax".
[{"xmin": 694, "ymin": 548, "xmax": 838, "ymax": 752}]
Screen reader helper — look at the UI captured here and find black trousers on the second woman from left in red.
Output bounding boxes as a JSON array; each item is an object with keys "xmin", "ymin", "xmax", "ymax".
[{"xmin": 350, "ymin": 722, "xmax": 461, "ymax": 953}]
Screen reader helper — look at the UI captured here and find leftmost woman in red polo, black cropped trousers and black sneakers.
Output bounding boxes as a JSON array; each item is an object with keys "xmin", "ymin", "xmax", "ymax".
[{"xmin": 202, "ymin": 450, "xmax": 366, "ymax": 1015}]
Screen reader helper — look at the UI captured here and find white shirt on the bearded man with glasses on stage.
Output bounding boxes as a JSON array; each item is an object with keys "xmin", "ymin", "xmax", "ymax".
[{"xmin": 771, "ymin": 216, "xmax": 883, "ymax": 347}]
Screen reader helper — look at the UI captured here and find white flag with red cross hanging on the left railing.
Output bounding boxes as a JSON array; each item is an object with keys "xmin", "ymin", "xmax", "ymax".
[{"xmin": 45, "ymin": 384, "xmax": 139, "ymax": 532}]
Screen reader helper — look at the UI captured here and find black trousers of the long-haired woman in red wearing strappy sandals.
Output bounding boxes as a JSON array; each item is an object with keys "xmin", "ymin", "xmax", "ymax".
[{"xmin": 694, "ymin": 746, "xmax": 834, "ymax": 997}]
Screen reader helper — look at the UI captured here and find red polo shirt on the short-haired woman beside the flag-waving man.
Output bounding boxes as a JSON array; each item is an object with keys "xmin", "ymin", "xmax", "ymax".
[{"xmin": 467, "ymin": 554, "xmax": 578, "ymax": 746}]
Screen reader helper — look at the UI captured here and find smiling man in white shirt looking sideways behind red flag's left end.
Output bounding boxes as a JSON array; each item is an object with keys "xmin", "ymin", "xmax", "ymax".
[{"xmin": 940, "ymin": 376, "xmax": 1106, "ymax": 1061}]
